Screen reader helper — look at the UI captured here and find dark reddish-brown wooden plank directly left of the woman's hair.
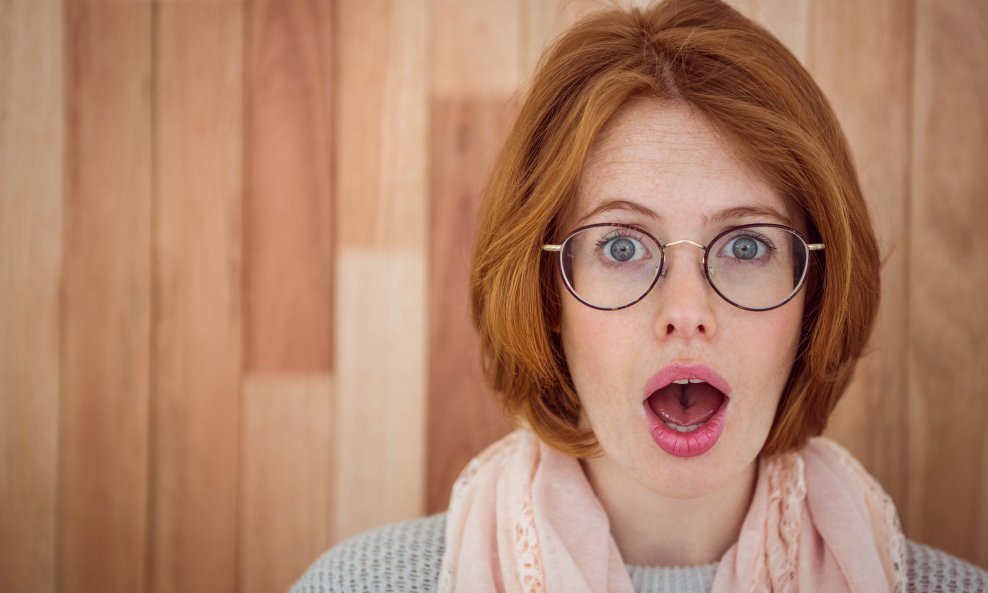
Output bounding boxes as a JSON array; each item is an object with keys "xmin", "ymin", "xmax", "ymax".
[{"xmin": 427, "ymin": 98, "xmax": 514, "ymax": 513}]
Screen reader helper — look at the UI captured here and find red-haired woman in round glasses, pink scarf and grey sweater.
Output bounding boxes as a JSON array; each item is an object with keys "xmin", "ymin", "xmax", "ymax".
[{"xmin": 295, "ymin": 0, "xmax": 988, "ymax": 593}]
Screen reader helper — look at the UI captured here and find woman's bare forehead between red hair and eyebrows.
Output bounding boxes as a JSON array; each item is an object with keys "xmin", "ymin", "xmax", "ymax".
[{"xmin": 573, "ymin": 98, "xmax": 789, "ymax": 227}]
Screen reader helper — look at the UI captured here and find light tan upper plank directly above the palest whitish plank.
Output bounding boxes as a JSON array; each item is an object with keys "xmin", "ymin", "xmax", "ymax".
[{"xmin": 335, "ymin": 0, "xmax": 428, "ymax": 250}]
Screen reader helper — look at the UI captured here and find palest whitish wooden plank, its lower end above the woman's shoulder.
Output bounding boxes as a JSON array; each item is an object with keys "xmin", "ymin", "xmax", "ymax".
[{"xmin": 333, "ymin": 252, "xmax": 427, "ymax": 542}]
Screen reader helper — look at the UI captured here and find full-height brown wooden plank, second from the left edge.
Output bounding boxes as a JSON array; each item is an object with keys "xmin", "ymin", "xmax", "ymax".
[{"xmin": 57, "ymin": 2, "xmax": 151, "ymax": 592}]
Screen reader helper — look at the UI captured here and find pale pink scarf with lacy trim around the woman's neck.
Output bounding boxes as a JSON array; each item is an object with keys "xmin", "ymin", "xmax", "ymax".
[{"xmin": 439, "ymin": 429, "xmax": 905, "ymax": 593}]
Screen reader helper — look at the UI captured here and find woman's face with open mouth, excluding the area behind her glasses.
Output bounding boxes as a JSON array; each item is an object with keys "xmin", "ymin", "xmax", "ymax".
[{"xmin": 559, "ymin": 99, "xmax": 804, "ymax": 498}]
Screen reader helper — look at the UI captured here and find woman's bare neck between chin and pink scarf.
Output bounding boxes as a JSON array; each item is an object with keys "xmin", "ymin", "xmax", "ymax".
[{"xmin": 580, "ymin": 458, "xmax": 757, "ymax": 566}]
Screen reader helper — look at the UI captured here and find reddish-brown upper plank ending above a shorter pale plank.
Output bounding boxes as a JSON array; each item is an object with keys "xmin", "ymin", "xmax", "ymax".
[{"xmin": 245, "ymin": 0, "xmax": 334, "ymax": 372}]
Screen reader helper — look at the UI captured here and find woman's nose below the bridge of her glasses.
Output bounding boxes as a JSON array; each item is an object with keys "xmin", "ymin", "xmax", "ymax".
[{"xmin": 654, "ymin": 241, "xmax": 717, "ymax": 339}]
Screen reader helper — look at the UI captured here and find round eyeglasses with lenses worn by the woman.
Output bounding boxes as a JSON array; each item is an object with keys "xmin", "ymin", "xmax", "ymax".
[{"xmin": 542, "ymin": 223, "xmax": 824, "ymax": 311}]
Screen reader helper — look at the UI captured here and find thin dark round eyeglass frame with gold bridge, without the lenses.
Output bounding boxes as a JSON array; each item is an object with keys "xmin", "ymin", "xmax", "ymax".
[{"xmin": 542, "ymin": 222, "xmax": 826, "ymax": 312}]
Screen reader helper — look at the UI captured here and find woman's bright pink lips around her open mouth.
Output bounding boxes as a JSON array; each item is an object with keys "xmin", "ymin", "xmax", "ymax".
[{"xmin": 642, "ymin": 364, "xmax": 731, "ymax": 457}]
